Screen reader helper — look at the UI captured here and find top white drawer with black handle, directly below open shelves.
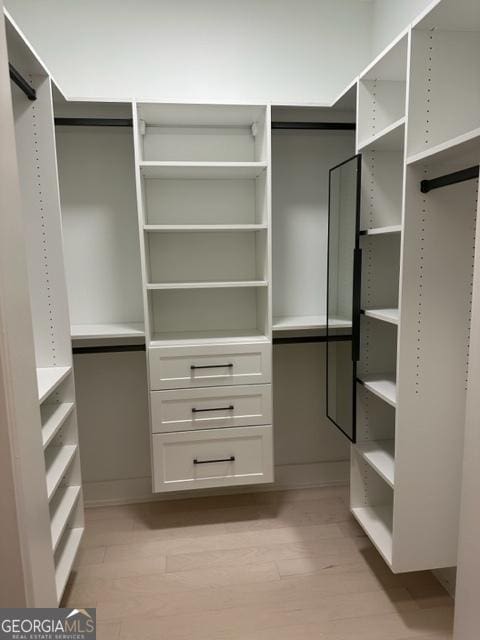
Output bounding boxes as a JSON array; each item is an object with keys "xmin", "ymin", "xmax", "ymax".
[{"xmin": 148, "ymin": 343, "xmax": 272, "ymax": 391}]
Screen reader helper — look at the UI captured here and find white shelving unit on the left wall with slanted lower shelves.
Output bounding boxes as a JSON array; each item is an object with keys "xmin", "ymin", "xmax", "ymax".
[{"xmin": 7, "ymin": 13, "xmax": 84, "ymax": 603}]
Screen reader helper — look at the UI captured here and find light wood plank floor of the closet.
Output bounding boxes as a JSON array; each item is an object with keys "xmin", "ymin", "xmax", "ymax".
[{"xmin": 63, "ymin": 487, "xmax": 453, "ymax": 640}]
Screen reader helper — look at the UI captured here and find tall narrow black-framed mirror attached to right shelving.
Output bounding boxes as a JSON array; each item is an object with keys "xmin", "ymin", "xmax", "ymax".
[{"xmin": 326, "ymin": 155, "xmax": 361, "ymax": 442}]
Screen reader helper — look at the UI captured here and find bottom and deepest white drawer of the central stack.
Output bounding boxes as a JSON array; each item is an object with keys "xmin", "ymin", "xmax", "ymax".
[{"xmin": 152, "ymin": 426, "xmax": 273, "ymax": 492}]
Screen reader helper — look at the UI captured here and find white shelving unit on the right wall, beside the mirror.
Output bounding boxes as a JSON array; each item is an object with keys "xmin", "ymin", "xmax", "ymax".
[{"xmin": 351, "ymin": 0, "xmax": 480, "ymax": 572}]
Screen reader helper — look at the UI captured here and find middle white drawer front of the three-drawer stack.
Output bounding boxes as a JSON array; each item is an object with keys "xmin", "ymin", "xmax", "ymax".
[{"xmin": 150, "ymin": 384, "xmax": 272, "ymax": 433}]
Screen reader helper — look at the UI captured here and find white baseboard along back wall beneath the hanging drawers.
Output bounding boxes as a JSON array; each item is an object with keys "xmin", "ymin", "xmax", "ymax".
[{"xmin": 83, "ymin": 460, "xmax": 349, "ymax": 507}]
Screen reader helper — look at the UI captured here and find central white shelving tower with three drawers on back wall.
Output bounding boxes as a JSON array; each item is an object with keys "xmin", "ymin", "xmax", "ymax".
[{"xmin": 133, "ymin": 103, "xmax": 273, "ymax": 491}]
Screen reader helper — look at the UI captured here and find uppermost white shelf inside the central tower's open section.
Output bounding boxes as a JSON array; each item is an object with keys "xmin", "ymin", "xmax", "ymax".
[{"xmin": 140, "ymin": 161, "xmax": 267, "ymax": 180}]
